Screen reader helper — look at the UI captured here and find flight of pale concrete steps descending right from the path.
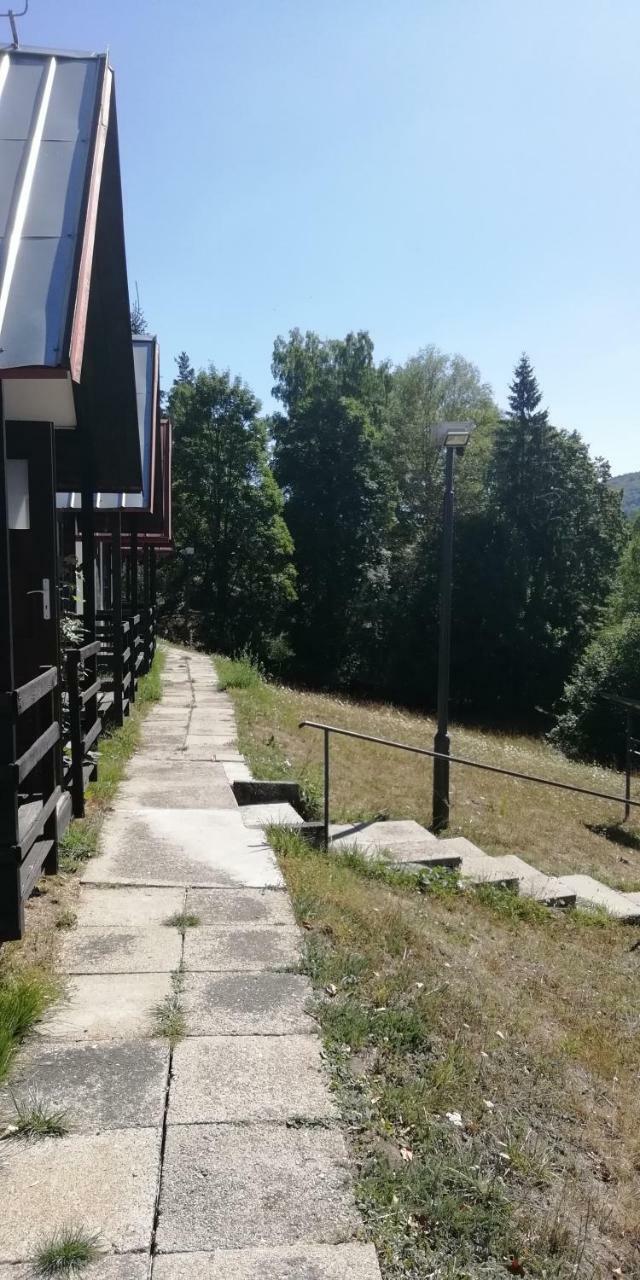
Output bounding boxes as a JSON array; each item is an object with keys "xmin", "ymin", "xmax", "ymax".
[{"xmin": 234, "ymin": 783, "xmax": 640, "ymax": 924}]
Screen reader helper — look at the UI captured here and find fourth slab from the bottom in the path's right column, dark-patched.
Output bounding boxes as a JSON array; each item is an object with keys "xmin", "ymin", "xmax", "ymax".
[{"xmin": 182, "ymin": 972, "xmax": 316, "ymax": 1036}]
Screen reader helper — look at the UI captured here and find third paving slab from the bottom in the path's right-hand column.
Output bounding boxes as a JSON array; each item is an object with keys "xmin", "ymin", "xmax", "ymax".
[{"xmin": 166, "ymin": 1036, "xmax": 338, "ymax": 1124}]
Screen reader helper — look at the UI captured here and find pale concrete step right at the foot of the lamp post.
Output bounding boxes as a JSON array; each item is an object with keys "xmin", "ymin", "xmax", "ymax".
[{"xmin": 329, "ymin": 818, "xmax": 460, "ymax": 868}]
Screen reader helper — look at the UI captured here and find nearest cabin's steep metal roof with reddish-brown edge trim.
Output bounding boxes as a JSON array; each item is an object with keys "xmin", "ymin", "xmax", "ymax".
[{"xmin": 0, "ymin": 49, "xmax": 141, "ymax": 489}]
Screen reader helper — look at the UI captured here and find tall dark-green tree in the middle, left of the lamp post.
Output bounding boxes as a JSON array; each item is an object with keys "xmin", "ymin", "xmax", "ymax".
[{"xmin": 270, "ymin": 329, "xmax": 392, "ymax": 685}]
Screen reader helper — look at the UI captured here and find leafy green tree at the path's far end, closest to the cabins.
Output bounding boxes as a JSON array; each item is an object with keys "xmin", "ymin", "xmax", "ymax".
[{"xmin": 165, "ymin": 361, "xmax": 296, "ymax": 660}]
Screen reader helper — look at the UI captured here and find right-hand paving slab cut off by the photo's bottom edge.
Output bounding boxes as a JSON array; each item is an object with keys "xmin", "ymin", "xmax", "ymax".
[{"xmin": 151, "ymin": 1244, "xmax": 380, "ymax": 1280}]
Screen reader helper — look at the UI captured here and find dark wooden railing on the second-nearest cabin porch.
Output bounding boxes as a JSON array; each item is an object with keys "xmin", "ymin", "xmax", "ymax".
[{"xmin": 64, "ymin": 640, "xmax": 102, "ymax": 818}]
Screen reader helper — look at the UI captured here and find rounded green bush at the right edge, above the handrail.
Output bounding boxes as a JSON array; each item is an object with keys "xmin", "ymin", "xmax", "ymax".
[{"xmin": 549, "ymin": 613, "xmax": 640, "ymax": 767}]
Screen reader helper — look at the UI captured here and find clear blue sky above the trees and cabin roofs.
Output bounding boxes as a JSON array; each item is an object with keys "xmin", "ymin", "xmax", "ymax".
[{"xmin": 20, "ymin": 0, "xmax": 640, "ymax": 471}]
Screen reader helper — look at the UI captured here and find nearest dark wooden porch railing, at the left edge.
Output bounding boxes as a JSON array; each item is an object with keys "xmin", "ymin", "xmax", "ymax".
[{"xmin": 0, "ymin": 667, "xmax": 61, "ymax": 942}]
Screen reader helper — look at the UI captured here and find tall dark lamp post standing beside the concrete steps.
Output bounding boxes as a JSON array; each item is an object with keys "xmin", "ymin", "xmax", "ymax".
[{"xmin": 431, "ymin": 422, "xmax": 475, "ymax": 832}]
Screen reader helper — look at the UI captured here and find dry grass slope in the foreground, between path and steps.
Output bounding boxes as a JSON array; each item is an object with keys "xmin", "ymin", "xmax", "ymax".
[{"xmin": 271, "ymin": 829, "xmax": 640, "ymax": 1280}]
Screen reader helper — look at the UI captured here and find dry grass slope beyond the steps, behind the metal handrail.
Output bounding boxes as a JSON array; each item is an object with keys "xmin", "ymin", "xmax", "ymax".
[{"xmin": 216, "ymin": 659, "xmax": 640, "ymax": 890}]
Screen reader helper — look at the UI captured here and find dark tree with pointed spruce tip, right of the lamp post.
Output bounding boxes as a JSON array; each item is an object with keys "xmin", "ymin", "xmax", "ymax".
[{"xmin": 476, "ymin": 356, "xmax": 623, "ymax": 714}]
